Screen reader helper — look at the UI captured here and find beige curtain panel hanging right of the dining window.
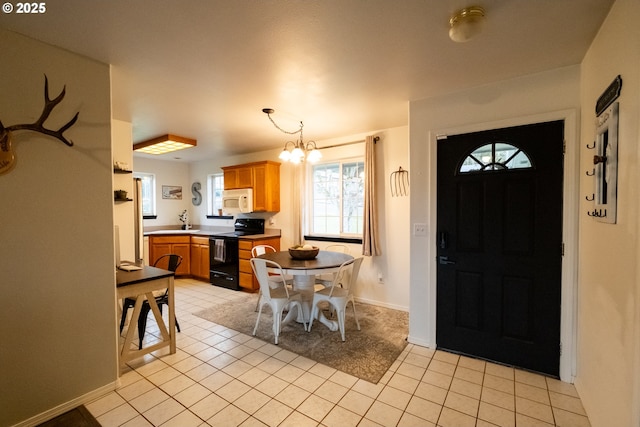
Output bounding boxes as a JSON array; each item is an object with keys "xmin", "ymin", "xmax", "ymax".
[{"xmin": 362, "ymin": 136, "xmax": 382, "ymax": 256}]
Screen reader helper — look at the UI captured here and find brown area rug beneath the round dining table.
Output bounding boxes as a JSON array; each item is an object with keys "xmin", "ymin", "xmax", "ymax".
[{"xmin": 194, "ymin": 294, "xmax": 409, "ymax": 384}]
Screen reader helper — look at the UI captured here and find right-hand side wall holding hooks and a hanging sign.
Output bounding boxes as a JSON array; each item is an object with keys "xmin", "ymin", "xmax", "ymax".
[{"xmin": 576, "ymin": 0, "xmax": 640, "ymax": 427}]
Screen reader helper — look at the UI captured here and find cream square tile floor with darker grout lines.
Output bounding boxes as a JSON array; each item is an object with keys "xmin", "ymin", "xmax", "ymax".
[{"xmin": 86, "ymin": 279, "xmax": 589, "ymax": 427}]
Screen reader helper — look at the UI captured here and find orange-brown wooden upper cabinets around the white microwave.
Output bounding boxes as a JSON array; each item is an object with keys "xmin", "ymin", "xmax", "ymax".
[{"xmin": 222, "ymin": 160, "xmax": 280, "ymax": 212}]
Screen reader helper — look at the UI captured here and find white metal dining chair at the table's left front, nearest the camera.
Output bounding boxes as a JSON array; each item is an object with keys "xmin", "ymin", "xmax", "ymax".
[{"xmin": 251, "ymin": 258, "xmax": 307, "ymax": 344}]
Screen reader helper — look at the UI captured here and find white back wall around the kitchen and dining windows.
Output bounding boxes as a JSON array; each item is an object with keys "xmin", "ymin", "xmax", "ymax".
[{"xmin": 134, "ymin": 127, "xmax": 409, "ymax": 311}]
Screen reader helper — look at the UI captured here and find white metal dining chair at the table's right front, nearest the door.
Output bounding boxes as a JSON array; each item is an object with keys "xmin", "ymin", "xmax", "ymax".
[{"xmin": 307, "ymin": 257, "xmax": 362, "ymax": 341}]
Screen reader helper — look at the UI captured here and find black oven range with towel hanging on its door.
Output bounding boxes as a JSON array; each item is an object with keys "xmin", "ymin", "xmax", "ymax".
[{"xmin": 209, "ymin": 218, "xmax": 264, "ymax": 291}]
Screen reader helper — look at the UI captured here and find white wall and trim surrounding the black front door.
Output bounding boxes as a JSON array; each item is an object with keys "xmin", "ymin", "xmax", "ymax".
[{"xmin": 409, "ymin": 66, "xmax": 580, "ymax": 368}]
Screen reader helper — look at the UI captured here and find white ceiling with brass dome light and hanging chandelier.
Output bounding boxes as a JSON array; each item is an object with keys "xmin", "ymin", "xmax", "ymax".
[{"xmin": 0, "ymin": 0, "xmax": 614, "ymax": 161}]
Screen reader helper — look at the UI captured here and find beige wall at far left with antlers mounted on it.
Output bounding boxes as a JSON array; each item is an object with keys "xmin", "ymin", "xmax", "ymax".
[{"xmin": 0, "ymin": 30, "xmax": 117, "ymax": 426}]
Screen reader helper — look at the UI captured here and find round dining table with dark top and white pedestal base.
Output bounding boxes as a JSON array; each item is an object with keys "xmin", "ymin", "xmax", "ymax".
[{"xmin": 258, "ymin": 250, "xmax": 353, "ymax": 331}]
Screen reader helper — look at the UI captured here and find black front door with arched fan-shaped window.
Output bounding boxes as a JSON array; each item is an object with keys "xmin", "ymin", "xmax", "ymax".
[{"xmin": 436, "ymin": 121, "xmax": 564, "ymax": 376}]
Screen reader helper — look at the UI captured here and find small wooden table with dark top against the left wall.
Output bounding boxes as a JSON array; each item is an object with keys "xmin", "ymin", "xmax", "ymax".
[{"xmin": 116, "ymin": 265, "xmax": 176, "ymax": 369}]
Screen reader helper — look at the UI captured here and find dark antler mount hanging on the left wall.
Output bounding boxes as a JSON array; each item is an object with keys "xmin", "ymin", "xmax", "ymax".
[{"xmin": 0, "ymin": 74, "xmax": 80, "ymax": 175}]
